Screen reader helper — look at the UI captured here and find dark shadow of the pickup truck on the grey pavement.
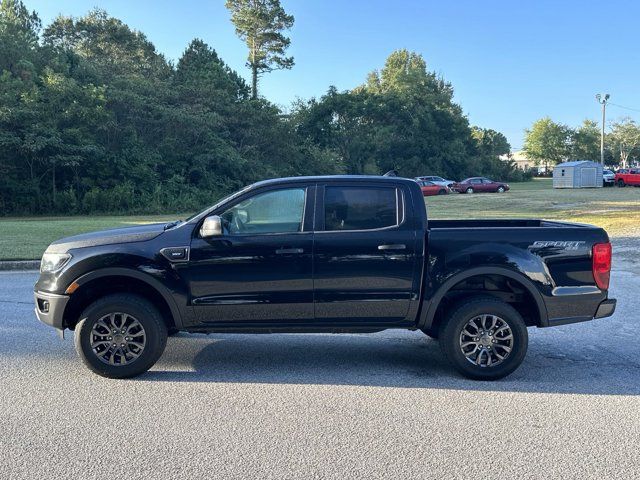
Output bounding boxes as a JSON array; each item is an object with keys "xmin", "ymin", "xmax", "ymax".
[{"xmin": 144, "ymin": 332, "xmax": 640, "ymax": 395}]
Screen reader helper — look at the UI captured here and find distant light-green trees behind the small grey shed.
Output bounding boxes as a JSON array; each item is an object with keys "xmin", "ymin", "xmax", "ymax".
[{"xmin": 523, "ymin": 117, "xmax": 640, "ymax": 168}]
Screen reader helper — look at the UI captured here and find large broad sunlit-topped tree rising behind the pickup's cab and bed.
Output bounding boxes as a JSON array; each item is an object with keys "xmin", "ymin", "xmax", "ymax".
[{"xmin": 292, "ymin": 50, "xmax": 513, "ymax": 182}]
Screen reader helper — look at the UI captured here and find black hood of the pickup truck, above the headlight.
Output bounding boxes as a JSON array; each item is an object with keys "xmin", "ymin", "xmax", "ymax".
[{"xmin": 45, "ymin": 223, "xmax": 165, "ymax": 253}]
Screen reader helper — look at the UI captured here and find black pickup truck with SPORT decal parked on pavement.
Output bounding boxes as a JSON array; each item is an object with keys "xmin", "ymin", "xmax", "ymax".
[{"xmin": 35, "ymin": 176, "xmax": 616, "ymax": 379}]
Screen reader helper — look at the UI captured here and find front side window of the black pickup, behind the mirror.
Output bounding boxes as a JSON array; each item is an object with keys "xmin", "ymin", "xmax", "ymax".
[{"xmin": 220, "ymin": 188, "xmax": 306, "ymax": 235}]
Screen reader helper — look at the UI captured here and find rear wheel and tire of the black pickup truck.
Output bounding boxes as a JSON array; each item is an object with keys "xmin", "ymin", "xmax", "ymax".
[{"xmin": 439, "ymin": 297, "xmax": 529, "ymax": 380}]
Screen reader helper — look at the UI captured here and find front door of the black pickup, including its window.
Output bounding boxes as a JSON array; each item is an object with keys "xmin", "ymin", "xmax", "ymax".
[{"xmin": 189, "ymin": 184, "xmax": 315, "ymax": 326}]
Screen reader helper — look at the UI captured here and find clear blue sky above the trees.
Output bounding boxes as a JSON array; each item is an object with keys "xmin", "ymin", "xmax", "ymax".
[{"xmin": 23, "ymin": 0, "xmax": 640, "ymax": 151}]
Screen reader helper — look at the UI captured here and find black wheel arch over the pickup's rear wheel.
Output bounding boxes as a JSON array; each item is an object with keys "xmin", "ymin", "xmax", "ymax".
[{"xmin": 418, "ymin": 267, "xmax": 548, "ymax": 330}]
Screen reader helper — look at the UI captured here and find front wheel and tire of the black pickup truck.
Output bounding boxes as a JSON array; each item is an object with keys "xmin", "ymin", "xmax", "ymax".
[{"xmin": 74, "ymin": 294, "xmax": 167, "ymax": 378}]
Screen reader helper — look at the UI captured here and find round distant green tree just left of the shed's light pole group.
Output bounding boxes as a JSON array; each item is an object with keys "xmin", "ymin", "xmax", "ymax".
[{"xmin": 524, "ymin": 117, "xmax": 571, "ymax": 169}]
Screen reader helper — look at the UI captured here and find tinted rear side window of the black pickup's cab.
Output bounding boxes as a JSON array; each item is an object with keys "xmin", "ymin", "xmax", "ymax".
[{"xmin": 324, "ymin": 187, "xmax": 398, "ymax": 231}]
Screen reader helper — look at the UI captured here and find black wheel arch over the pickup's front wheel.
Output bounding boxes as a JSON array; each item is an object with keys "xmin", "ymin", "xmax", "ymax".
[{"xmin": 63, "ymin": 268, "xmax": 183, "ymax": 329}]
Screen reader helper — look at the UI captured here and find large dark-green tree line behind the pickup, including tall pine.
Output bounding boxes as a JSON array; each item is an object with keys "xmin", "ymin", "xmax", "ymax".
[{"xmin": 0, "ymin": 0, "xmax": 522, "ymax": 215}]
